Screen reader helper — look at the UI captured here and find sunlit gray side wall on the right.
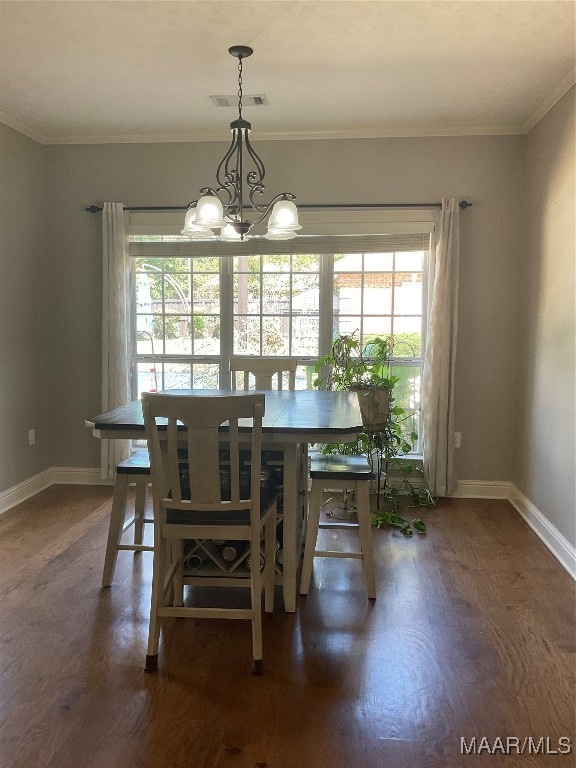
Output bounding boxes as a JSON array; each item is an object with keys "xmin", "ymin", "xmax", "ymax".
[{"xmin": 513, "ymin": 88, "xmax": 576, "ymax": 544}]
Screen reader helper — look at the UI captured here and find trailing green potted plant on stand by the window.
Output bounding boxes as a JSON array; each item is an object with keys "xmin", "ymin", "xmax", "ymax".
[{"xmin": 314, "ymin": 334, "xmax": 436, "ymax": 536}]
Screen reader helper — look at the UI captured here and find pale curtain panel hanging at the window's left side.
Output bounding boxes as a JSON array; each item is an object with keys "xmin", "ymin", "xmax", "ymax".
[{"xmin": 101, "ymin": 203, "xmax": 131, "ymax": 480}]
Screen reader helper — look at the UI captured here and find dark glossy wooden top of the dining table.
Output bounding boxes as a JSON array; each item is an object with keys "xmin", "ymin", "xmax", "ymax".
[{"xmin": 86, "ymin": 389, "xmax": 362, "ymax": 442}]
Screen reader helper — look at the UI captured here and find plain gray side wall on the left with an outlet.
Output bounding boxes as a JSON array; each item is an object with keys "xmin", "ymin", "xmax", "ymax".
[{"xmin": 0, "ymin": 124, "xmax": 50, "ymax": 492}]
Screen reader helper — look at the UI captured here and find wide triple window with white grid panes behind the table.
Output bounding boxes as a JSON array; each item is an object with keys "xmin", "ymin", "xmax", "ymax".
[{"xmin": 130, "ymin": 208, "xmax": 432, "ymax": 450}]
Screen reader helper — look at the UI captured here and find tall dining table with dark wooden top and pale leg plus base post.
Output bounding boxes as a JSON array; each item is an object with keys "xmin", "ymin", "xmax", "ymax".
[{"xmin": 85, "ymin": 389, "xmax": 362, "ymax": 612}]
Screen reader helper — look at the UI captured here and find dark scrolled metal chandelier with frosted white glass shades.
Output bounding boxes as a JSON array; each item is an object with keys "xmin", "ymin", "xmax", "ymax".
[{"xmin": 182, "ymin": 45, "xmax": 301, "ymax": 241}]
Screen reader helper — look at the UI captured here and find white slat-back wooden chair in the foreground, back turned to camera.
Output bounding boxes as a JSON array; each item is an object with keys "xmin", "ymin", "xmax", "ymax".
[{"xmin": 142, "ymin": 392, "xmax": 276, "ymax": 674}]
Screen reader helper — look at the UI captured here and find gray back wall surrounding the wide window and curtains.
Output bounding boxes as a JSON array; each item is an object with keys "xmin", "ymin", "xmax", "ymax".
[{"xmin": 47, "ymin": 136, "xmax": 525, "ymax": 480}]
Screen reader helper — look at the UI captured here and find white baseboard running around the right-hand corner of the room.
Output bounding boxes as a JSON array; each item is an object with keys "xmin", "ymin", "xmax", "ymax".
[{"xmin": 452, "ymin": 480, "xmax": 576, "ymax": 580}]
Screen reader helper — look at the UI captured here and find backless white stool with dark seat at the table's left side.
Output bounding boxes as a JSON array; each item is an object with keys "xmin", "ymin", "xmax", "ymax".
[{"xmin": 102, "ymin": 450, "xmax": 154, "ymax": 587}]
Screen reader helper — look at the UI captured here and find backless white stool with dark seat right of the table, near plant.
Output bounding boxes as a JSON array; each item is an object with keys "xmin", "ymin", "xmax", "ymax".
[{"xmin": 300, "ymin": 455, "xmax": 376, "ymax": 599}]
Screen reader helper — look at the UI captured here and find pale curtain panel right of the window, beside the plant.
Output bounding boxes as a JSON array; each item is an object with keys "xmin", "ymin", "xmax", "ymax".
[{"xmin": 422, "ymin": 197, "xmax": 460, "ymax": 496}]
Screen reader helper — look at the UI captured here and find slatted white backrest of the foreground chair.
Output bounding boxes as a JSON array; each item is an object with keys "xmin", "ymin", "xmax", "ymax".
[{"xmin": 142, "ymin": 392, "xmax": 265, "ymax": 523}]
